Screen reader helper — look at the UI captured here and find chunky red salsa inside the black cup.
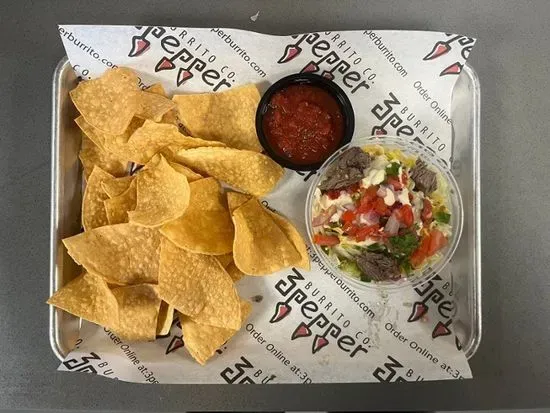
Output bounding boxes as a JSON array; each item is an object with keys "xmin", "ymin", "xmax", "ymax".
[{"xmin": 262, "ymin": 85, "xmax": 344, "ymax": 165}]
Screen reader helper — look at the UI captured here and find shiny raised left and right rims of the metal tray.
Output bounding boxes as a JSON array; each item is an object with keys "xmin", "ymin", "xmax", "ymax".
[{"xmin": 48, "ymin": 56, "xmax": 482, "ymax": 361}]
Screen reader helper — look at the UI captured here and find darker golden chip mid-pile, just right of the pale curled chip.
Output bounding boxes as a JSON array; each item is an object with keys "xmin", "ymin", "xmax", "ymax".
[{"xmin": 160, "ymin": 178, "xmax": 234, "ymax": 255}]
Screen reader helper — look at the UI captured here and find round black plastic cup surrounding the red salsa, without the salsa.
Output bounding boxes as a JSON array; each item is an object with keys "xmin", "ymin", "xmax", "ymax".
[{"xmin": 256, "ymin": 73, "xmax": 355, "ymax": 171}]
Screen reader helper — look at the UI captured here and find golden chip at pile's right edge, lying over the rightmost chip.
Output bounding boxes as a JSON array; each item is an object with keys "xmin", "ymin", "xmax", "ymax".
[{"xmin": 233, "ymin": 199, "xmax": 301, "ymax": 275}]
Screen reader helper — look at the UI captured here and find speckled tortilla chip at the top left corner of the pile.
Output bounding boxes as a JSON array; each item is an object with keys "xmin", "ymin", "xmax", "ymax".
[{"xmin": 70, "ymin": 68, "xmax": 140, "ymax": 135}]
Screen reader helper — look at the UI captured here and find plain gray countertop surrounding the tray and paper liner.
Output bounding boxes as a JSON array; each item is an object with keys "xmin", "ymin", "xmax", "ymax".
[{"xmin": 0, "ymin": 0, "xmax": 550, "ymax": 411}]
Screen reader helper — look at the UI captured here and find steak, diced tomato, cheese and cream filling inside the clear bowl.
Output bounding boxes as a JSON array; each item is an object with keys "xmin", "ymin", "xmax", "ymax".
[{"xmin": 312, "ymin": 145, "xmax": 452, "ymax": 282}]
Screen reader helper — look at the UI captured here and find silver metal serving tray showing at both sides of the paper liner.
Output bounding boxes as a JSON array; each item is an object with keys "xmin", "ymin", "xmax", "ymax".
[{"xmin": 49, "ymin": 57, "xmax": 481, "ymax": 360}]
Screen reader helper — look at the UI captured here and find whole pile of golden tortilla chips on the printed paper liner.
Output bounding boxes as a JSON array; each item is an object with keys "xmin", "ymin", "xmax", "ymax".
[{"xmin": 48, "ymin": 68, "xmax": 309, "ymax": 364}]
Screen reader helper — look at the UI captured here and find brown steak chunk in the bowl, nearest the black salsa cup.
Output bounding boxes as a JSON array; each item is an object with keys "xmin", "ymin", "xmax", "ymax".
[{"xmin": 319, "ymin": 147, "xmax": 372, "ymax": 191}]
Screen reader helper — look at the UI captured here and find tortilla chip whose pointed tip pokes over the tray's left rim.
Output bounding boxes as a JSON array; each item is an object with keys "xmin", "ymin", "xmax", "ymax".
[{"xmin": 48, "ymin": 273, "xmax": 118, "ymax": 328}]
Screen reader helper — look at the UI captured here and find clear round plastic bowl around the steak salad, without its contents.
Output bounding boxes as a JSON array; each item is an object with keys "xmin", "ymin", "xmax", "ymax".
[{"xmin": 305, "ymin": 136, "xmax": 464, "ymax": 292}]
